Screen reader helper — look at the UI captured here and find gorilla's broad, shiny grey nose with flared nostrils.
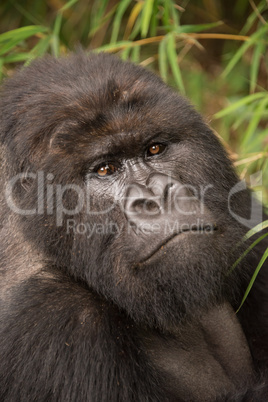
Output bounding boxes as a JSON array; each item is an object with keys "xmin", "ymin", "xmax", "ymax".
[{"xmin": 125, "ymin": 174, "xmax": 178, "ymax": 221}]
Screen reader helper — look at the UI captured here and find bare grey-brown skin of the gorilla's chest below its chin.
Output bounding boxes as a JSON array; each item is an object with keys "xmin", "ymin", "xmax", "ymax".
[{"xmin": 140, "ymin": 305, "xmax": 253, "ymax": 402}]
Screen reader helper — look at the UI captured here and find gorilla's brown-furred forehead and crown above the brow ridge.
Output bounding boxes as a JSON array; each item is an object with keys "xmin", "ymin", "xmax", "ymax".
[{"xmin": 1, "ymin": 53, "xmax": 203, "ymax": 150}]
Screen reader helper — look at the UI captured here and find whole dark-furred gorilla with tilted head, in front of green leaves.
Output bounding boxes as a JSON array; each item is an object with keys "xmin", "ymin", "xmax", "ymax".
[{"xmin": 0, "ymin": 52, "xmax": 268, "ymax": 402}]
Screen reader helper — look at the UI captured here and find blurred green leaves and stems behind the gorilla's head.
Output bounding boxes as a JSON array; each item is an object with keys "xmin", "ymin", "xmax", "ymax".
[{"xmin": 0, "ymin": 0, "xmax": 268, "ymax": 205}]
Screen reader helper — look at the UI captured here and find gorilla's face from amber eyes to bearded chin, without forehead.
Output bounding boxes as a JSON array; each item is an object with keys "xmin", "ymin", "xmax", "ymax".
[{"xmin": 74, "ymin": 137, "xmax": 245, "ymax": 326}]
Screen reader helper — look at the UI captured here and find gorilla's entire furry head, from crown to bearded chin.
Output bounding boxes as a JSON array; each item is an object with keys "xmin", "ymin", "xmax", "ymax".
[{"xmin": 1, "ymin": 54, "xmax": 249, "ymax": 327}]
